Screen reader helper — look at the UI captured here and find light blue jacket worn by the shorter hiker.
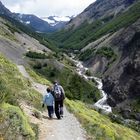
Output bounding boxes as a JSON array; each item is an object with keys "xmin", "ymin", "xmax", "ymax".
[{"xmin": 43, "ymin": 92, "xmax": 54, "ymax": 106}]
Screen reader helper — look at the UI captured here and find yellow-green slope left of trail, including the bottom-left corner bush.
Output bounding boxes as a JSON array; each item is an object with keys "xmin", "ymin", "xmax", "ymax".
[{"xmin": 0, "ymin": 54, "xmax": 42, "ymax": 140}]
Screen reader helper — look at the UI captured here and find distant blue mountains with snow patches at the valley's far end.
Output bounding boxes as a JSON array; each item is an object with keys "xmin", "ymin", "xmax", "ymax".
[{"xmin": 0, "ymin": 2, "xmax": 69, "ymax": 33}]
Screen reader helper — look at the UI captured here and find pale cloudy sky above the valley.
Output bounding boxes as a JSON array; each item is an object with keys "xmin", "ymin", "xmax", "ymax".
[{"xmin": 1, "ymin": 0, "xmax": 95, "ymax": 17}]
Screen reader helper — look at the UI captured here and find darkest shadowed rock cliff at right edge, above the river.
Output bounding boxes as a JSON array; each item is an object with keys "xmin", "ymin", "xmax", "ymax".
[{"xmin": 103, "ymin": 20, "xmax": 140, "ymax": 106}]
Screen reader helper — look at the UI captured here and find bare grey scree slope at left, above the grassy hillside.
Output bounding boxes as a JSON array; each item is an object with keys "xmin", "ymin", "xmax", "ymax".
[{"xmin": 0, "ymin": 18, "xmax": 51, "ymax": 64}]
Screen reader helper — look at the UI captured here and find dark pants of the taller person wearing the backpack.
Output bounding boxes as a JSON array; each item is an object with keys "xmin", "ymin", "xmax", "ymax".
[{"xmin": 55, "ymin": 100, "xmax": 63, "ymax": 119}]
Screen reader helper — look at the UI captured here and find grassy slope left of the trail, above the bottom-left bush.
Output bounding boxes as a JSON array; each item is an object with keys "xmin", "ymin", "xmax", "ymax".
[{"xmin": 0, "ymin": 55, "xmax": 42, "ymax": 108}]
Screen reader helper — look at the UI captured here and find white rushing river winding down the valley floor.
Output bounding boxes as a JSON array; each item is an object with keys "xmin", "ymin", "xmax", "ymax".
[{"xmin": 72, "ymin": 59, "xmax": 112, "ymax": 113}]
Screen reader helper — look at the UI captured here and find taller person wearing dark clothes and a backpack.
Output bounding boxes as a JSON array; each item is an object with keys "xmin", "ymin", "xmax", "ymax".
[{"xmin": 52, "ymin": 81, "xmax": 65, "ymax": 119}]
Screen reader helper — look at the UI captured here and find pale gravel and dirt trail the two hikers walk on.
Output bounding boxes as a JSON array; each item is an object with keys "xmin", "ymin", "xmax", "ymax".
[{"xmin": 18, "ymin": 65, "xmax": 86, "ymax": 140}]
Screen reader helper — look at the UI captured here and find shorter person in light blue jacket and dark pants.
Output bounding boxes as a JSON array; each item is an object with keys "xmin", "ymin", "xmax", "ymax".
[{"xmin": 42, "ymin": 87, "xmax": 54, "ymax": 119}]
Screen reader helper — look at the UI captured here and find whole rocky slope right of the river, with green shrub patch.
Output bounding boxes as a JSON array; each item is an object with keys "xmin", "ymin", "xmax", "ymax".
[{"xmin": 82, "ymin": 16, "xmax": 140, "ymax": 120}]
